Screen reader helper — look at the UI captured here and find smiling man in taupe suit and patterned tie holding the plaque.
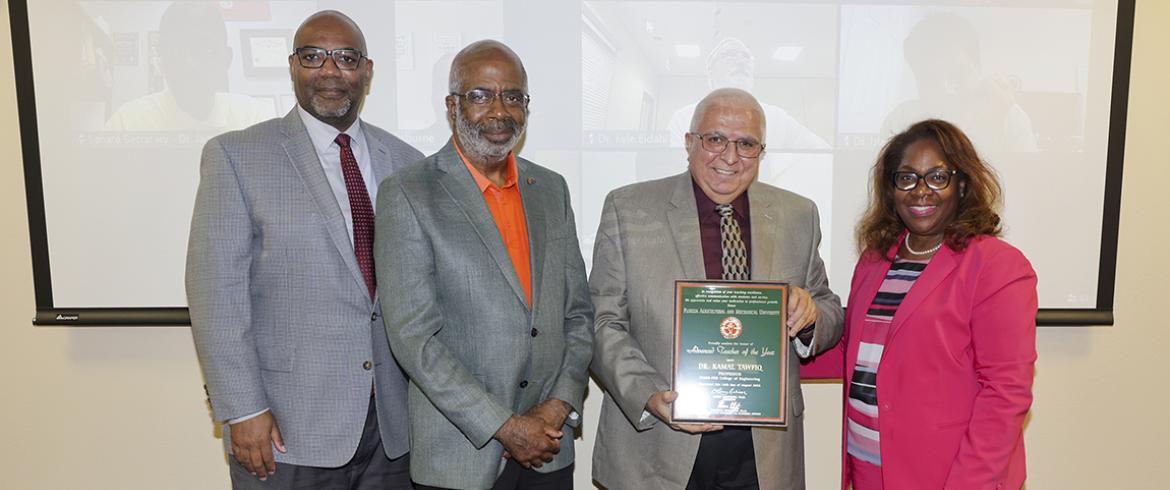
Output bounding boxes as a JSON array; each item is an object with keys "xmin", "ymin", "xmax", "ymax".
[{"xmin": 590, "ymin": 89, "xmax": 842, "ymax": 490}]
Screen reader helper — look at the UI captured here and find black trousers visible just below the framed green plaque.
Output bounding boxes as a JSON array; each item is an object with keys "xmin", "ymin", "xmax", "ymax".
[{"xmin": 687, "ymin": 427, "xmax": 759, "ymax": 490}]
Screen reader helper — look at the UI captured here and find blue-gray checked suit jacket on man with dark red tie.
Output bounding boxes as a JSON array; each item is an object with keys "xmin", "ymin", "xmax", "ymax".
[{"xmin": 186, "ymin": 109, "xmax": 421, "ymax": 467}]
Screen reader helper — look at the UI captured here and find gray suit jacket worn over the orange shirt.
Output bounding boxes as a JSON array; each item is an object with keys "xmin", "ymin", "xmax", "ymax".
[{"xmin": 374, "ymin": 142, "xmax": 593, "ymax": 489}]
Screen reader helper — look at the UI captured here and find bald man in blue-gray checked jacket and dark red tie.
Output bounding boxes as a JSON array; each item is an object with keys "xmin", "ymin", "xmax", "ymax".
[{"xmin": 187, "ymin": 11, "xmax": 422, "ymax": 489}]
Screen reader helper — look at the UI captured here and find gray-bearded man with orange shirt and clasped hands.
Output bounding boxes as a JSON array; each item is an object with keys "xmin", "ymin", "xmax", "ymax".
[{"xmin": 374, "ymin": 41, "xmax": 593, "ymax": 489}]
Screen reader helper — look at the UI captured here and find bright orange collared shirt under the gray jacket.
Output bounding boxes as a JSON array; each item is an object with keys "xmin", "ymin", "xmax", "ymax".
[{"xmin": 455, "ymin": 145, "xmax": 532, "ymax": 305}]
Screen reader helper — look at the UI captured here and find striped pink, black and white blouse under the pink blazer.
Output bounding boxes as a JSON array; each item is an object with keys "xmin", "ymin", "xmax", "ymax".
[{"xmin": 846, "ymin": 257, "xmax": 930, "ymax": 488}]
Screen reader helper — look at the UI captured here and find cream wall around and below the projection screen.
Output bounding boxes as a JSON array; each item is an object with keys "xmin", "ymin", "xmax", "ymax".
[{"xmin": 0, "ymin": 0, "xmax": 1170, "ymax": 489}]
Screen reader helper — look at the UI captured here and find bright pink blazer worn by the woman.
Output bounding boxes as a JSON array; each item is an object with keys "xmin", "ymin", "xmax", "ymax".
[{"xmin": 801, "ymin": 236, "xmax": 1037, "ymax": 490}]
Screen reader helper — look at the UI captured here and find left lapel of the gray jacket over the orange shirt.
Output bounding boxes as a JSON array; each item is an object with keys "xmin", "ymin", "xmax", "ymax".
[{"xmin": 435, "ymin": 142, "xmax": 535, "ymax": 305}]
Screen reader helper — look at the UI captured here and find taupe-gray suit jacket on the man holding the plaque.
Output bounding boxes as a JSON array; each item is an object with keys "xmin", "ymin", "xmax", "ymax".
[{"xmin": 590, "ymin": 173, "xmax": 842, "ymax": 490}]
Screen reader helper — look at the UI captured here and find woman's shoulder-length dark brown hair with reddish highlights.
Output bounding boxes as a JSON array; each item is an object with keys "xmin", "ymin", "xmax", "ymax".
[{"xmin": 856, "ymin": 119, "xmax": 1003, "ymax": 260}]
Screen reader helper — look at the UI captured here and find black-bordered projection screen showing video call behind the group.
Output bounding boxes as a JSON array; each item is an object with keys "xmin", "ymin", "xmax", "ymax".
[{"xmin": 8, "ymin": 0, "xmax": 1134, "ymax": 325}]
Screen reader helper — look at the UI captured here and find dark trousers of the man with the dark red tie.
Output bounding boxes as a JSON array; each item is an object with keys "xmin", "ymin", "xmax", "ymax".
[{"xmin": 229, "ymin": 396, "xmax": 411, "ymax": 490}]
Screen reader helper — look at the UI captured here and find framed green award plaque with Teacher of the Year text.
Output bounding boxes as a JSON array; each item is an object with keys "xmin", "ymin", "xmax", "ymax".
[{"xmin": 670, "ymin": 281, "xmax": 789, "ymax": 427}]
